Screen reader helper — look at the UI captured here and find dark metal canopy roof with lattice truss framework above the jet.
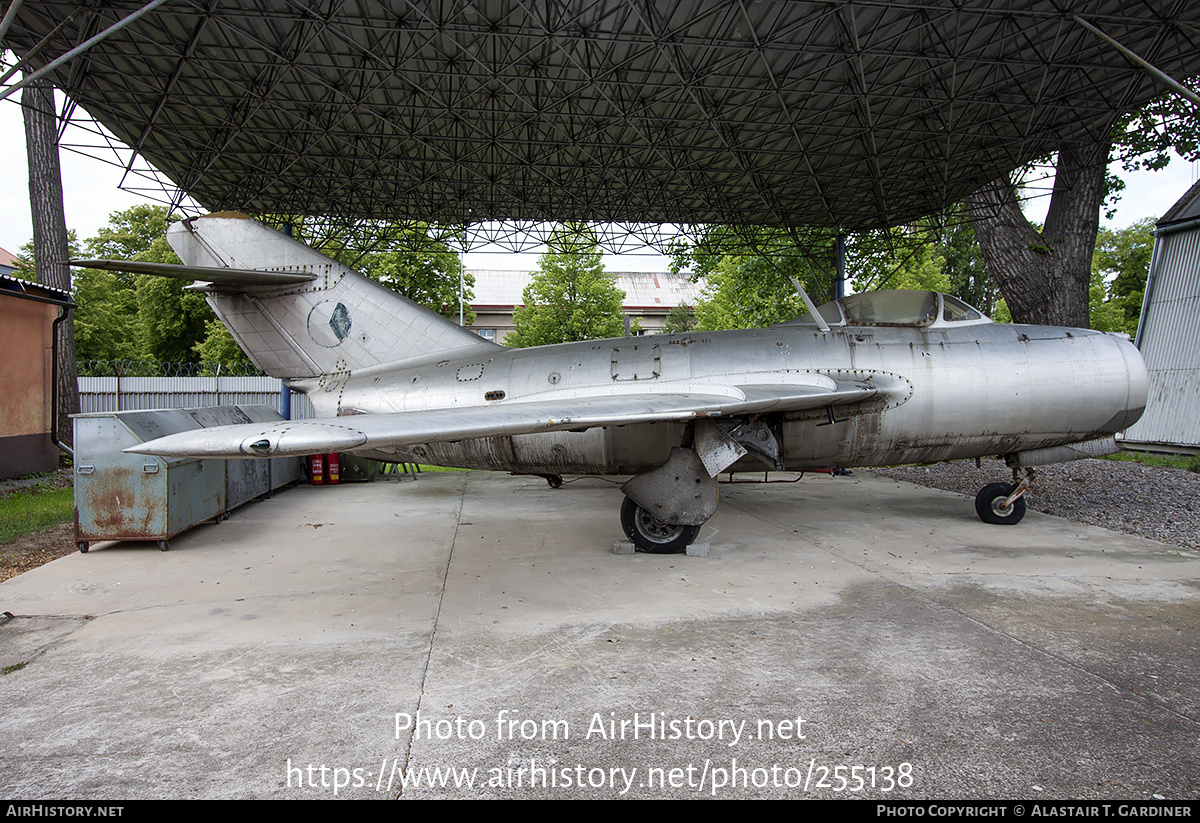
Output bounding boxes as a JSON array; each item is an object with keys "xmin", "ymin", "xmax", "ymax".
[{"xmin": 7, "ymin": 0, "xmax": 1200, "ymax": 229}]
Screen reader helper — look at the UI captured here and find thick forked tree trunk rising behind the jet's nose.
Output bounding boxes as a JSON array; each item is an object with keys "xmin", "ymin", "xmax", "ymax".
[{"xmin": 966, "ymin": 137, "xmax": 1111, "ymax": 329}]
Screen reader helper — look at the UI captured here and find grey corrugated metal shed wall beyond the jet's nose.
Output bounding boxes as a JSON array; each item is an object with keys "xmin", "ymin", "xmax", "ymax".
[{"xmin": 1126, "ymin": 226, "xmax": 1200, "ymax": 449}]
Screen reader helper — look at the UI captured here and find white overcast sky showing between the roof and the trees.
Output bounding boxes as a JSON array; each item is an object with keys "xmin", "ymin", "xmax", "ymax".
[{"xmin": 0, "ymin": 95, "xmax": 1196, "ymax": 271}]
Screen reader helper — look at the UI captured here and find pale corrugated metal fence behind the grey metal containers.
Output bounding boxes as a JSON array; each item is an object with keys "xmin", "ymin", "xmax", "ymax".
[{"xmin": 79, "ymin": 377, "xmax": 316, "ymax": 420}]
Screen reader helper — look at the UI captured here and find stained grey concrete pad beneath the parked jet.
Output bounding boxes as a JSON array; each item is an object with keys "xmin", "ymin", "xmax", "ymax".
[{"xmin": 0, "ymin": 471, "xmax": 1200, "ymax": 799}]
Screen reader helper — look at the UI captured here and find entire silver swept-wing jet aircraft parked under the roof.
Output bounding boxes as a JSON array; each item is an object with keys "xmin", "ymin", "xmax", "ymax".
[{"xmin": 74, "ymin": 214, "xmax": 1147, "ymax": 553}]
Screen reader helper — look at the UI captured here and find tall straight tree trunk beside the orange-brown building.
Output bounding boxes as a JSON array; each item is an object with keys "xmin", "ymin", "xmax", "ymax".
[{"xmin": 20, "ymin": 78, "xmax": 79, "ymax": 444}]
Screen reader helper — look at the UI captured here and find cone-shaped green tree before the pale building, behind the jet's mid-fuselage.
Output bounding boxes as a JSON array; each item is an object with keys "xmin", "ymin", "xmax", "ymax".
[{"xmin": 504, "ymin": 224, "xmax": 625, "ymax": 348}]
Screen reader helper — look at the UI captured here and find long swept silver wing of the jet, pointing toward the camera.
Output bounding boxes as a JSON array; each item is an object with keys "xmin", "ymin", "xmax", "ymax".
[{"xmin": 125, "ymin": 380, "xmax": 876, "ymax": 458}]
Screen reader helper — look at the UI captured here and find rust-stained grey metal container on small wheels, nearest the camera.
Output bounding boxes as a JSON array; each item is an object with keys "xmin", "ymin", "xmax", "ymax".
[{"xmin": 74, "ymin": 409, "xmax": 227, "ymax": 552}]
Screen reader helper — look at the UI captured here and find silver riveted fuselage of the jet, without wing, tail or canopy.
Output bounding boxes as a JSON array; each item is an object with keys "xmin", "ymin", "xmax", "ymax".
[{"xmin": 292, "ymin": 323, "xmax": 1147, "ymax": 474}]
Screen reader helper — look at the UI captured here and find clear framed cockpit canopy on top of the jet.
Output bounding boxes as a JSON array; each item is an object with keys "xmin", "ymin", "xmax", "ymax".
[{"xmin": 782, "ymin": 290, "xmax": 991, "ymax": 328}]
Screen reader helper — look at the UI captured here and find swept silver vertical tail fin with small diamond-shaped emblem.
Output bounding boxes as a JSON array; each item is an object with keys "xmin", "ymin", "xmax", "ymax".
[{"xmin": 167, "ymin": 212, "xmax": 494, "ymax": 379}]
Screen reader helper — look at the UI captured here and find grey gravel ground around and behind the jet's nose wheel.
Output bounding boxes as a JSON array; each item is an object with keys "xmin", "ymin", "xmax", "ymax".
[{"xmin": 870, "ymin": 459, "xmax": 1200, "ymax": 551}]
